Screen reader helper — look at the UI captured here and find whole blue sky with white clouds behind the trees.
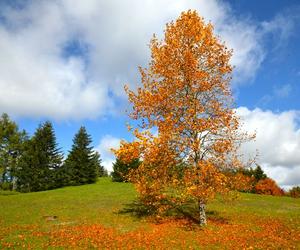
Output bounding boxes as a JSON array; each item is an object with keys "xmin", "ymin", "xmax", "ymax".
[{"xmin": 0, "ymin": 0, "xmax": 300, "ymax": 189}]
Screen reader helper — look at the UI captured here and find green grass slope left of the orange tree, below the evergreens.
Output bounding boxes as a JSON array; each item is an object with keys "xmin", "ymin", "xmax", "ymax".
[{"xmin": 0, "ymin": 178, "xmax": 141, "ymax": 228}]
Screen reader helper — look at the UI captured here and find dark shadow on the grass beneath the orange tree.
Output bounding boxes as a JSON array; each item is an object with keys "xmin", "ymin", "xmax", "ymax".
[{"xmin": 117, "ymin": 200, "xmax": 229, "ymax": 226}]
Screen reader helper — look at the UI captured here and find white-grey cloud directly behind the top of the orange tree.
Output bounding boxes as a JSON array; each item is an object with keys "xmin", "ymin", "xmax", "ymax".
[{"xmin": 64, "ymin": 0, "xmax": 271, "ymax": 86}]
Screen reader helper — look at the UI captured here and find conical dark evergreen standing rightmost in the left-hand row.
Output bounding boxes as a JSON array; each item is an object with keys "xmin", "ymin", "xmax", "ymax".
[{"xmin": 62, "ymin": 127, "xmax": 100, "ymax": 185}]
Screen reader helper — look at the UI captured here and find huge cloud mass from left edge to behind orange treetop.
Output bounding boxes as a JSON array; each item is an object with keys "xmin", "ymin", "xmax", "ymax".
[{"xmin": 0, "ymin": 0, "xmax": 292, "ymax": 119}]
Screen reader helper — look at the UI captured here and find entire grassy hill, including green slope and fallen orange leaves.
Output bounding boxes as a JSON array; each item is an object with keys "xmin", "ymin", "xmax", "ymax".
[{"xmin": 0, "ymin": 178, "xmax": 300, "ymax": 249}]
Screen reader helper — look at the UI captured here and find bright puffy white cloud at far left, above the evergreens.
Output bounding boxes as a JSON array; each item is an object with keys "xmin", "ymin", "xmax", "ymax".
[{"xmin": 0, "ymin": 0, "xmax": 111, "ymax": 119}]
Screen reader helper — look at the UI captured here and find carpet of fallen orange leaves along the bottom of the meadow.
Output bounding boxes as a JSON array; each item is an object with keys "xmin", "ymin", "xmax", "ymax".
[{"xmin": 0, "ymin": 214, "xmax": 300, "ymax": 249}]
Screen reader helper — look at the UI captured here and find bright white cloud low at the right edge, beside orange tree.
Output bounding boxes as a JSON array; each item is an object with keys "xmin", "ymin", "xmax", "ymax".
[{"xmin": 237, "ymin": 107, "xmax": 300, "ymax": 187}]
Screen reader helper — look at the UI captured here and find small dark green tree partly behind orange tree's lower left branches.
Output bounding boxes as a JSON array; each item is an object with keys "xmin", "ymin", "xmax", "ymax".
[{"xmin": 111, "ymin": 159, "xmax": 141, "ymax": 182}]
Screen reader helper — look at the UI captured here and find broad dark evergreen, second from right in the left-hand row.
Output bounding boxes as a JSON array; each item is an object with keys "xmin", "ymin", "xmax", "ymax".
[{"xmin": 16, "ymin": 121, "xmax": 63, "ymax": 192}]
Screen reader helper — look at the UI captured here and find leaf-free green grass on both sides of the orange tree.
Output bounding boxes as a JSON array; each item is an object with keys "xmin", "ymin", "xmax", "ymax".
[{"xmin": 0, "ymin": 178, "xmax": 300, "ymax": 248}]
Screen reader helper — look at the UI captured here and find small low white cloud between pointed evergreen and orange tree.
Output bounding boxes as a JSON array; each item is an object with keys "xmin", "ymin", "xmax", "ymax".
[{"xmin": 96, "ymin": 135, "xmax": 120, "ymax": 172}]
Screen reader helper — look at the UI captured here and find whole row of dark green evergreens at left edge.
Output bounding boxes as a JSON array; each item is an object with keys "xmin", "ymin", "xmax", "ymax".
[{"xmin": 0, "ymin": 114, "xmax": 107, "ymax": 192}]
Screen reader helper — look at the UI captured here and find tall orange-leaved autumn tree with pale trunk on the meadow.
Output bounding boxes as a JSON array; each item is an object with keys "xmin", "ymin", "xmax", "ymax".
[{"xmin": 115, "ymin": 11, "xmax": 250, "ymax": 224}]
